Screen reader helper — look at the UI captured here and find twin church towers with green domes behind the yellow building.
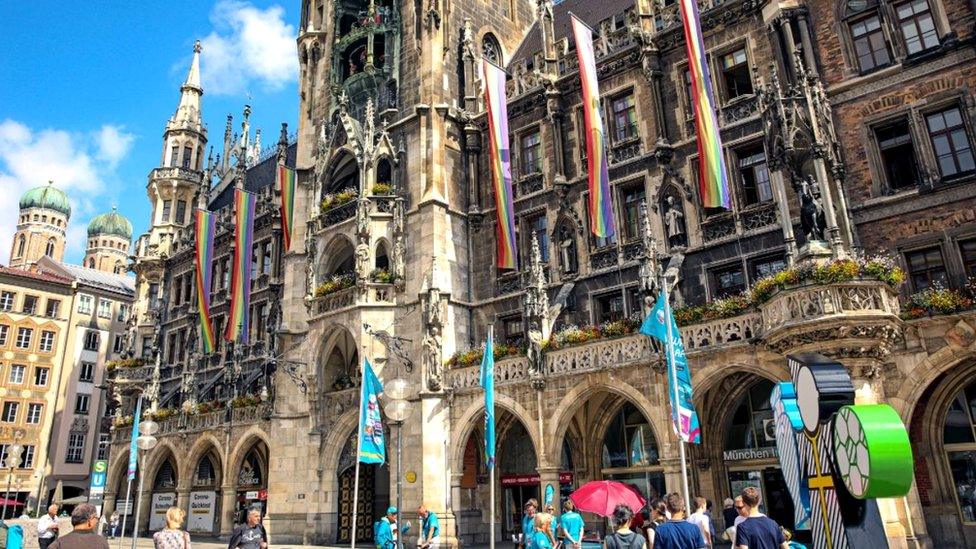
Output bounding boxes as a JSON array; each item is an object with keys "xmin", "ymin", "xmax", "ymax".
[{"xmin": 9, "ymin": 182, "xmax": 132, "ymax": 274}]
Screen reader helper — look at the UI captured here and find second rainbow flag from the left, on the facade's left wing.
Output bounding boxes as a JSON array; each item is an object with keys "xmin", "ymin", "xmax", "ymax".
[{"xmin": 224, "ymin": 189, "xmax": 255, "ymax": 344}]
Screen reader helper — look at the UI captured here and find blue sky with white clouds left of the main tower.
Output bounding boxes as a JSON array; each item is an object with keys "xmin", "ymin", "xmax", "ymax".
[{"xmin": 0, "ymin": 0, "xmax": 300, "ymax": 264}]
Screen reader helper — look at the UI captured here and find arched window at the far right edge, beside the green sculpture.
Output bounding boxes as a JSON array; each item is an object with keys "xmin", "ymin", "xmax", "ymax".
[{"xmin": 942, "ymin": 383, "xmax": 976, "ymax": 523}]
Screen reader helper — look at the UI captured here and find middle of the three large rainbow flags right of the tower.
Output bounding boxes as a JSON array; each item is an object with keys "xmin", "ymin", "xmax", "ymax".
[{"xmin": 570, "ymin": 14, "xmax": 616, "ymax": 238}]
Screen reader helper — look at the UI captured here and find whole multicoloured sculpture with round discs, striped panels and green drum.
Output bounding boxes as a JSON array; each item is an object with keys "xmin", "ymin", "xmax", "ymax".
[{"xmin": 770, "ymin": 353, "xmax": 914, "ymax": 549}]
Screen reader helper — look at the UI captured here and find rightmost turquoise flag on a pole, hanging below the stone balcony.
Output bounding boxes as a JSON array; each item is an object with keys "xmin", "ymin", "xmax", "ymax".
[{"xmin": 640, "ymin": 292, "xmax": 701, "ymax": 444}]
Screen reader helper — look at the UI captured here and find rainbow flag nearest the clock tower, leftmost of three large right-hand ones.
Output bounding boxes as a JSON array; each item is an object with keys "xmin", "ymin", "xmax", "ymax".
[{"xmin": 481, "ymin": 59, "xmax": 518, "ymax": 269}]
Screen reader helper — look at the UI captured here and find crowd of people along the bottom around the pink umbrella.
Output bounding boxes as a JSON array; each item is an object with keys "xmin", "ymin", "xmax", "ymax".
[{"xmin": 515, "ymin": 487, "xmax": 805, "ymax": 549}]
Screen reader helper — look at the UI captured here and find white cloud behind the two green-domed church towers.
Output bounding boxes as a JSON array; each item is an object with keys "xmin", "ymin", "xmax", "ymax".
[{"xmin": 0, "ymin": 119, "xmax": 135, "ymax": 263}]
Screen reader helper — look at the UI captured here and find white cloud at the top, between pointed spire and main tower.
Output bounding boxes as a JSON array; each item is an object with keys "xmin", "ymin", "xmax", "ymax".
[{"xmin": 200, "ymin": 0, "xmax": 298, "ymax": 95}]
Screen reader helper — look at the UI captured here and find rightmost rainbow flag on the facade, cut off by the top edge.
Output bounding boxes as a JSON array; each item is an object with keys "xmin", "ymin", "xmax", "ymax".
[{"xmin": 680, "ymin": 0, "xmax": 732, "ymax": 210}]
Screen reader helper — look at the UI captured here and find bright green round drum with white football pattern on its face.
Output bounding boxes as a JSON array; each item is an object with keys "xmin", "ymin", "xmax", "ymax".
[{"xmin": 833, "ymin": 404, "xmax": 914, "ymax": 499}]
